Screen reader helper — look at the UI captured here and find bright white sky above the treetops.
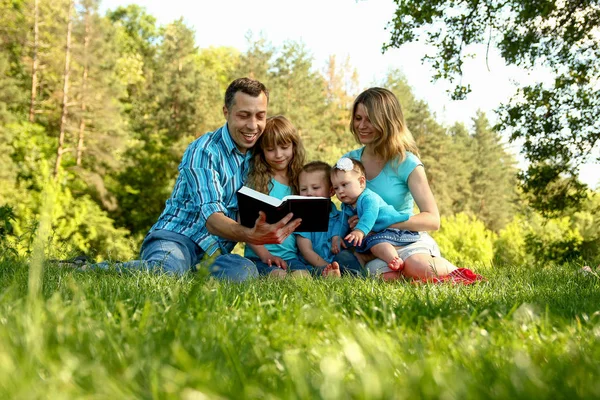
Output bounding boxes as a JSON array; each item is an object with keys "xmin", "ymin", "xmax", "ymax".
[{"xmin": 101, "ymin": 0, "xmax": 600, "ymax": 187}]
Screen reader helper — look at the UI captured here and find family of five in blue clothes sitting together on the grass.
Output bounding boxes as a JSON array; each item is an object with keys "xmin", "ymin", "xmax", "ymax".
[{"xmin": 71, "ymin": 78, "xmax": 482, "ymax": 284}]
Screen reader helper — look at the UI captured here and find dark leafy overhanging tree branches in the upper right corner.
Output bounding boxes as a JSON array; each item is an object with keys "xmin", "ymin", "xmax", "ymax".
[{"xmin": 383, "ymin": 0, "xmax": 600, "ymax": 212}]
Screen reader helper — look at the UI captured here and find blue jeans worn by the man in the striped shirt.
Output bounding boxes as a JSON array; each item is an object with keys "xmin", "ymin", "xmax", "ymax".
[{"xmin": 93, "ymin": 230, "xmax": 258, "ymax": 282}]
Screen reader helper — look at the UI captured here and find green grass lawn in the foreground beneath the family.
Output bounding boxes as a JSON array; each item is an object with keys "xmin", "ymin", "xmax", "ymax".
[{"xmin": 0, "ymin": 262, "xmax": 600, "ymax": 399}]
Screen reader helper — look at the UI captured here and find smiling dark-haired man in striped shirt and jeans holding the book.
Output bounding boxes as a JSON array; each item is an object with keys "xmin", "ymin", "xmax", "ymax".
[{"xmin": 84, "ymin": 78, "xmax": 301, "ymax": 281}]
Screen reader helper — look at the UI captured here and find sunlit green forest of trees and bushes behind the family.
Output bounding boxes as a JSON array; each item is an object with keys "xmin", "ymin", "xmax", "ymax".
[{"xmin": 0, "ymin": 0, "xmax": 600, "ymax": 265}]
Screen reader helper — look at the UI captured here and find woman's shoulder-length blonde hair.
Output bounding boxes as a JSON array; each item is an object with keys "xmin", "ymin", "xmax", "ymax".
[{"xmin": 350, "ymin": 87, "xmax": 419, "ymax": 163}]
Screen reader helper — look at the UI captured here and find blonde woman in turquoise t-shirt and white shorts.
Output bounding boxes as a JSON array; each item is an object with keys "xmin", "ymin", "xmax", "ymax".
[{"xmin": 337, "ymin": 87, "xmax": 482, "ymax": 283}]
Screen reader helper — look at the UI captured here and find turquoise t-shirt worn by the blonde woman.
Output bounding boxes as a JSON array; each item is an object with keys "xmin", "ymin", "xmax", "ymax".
[{"xmin": 344, "ymin": 147, "xmax": 423, "ymax": 215}]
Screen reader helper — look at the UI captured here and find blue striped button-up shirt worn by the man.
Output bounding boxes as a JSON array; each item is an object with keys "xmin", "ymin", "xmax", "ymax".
[{"xmin": 150, "ymin": 124, "xmax": 251, "ymax": 255}]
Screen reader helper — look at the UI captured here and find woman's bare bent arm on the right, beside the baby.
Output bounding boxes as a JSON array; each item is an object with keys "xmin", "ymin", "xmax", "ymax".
[{"xmin": 390, "ymin": 165, "xmax": 440, "ymax": 231}]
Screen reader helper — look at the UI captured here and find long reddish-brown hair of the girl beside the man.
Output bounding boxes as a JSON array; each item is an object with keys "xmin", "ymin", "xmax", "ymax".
[{"xmin": 246, "ymin": 115, "xmax": 305, "ymax": 194}]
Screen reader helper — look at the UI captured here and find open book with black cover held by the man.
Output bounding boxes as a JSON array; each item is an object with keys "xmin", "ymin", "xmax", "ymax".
[{"xmin": 237, "ymin": 186, "xmax": 331, "ymax": 232}]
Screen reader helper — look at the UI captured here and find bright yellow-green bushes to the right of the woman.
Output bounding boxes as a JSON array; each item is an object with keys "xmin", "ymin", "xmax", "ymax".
[{"xmin": 433, "ymin": 192, "xmax": 600, "ymax": 266}]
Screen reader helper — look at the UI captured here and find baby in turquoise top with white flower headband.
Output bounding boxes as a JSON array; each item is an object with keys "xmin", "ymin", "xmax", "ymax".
[{"xmin": 331, "ymin": 157, "xmax": 420, "ymax": 271}]
